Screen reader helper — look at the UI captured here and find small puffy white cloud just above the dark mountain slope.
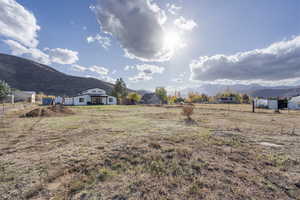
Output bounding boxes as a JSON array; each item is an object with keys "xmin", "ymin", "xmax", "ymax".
[{"xmin": 44, "ymin": 48, "xmax": 79, "ymax": 65}]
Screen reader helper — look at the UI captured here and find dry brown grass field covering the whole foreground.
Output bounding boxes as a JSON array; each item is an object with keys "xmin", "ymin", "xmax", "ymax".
[{"xmin": 0, "ymin": 105, "xmax": 300, "ymax": 200}]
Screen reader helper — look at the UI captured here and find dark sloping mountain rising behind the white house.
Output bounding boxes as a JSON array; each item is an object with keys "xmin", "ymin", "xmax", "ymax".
[{"xmin": 0, "ymin": 54, "xmax": 118, "ymax": 96}]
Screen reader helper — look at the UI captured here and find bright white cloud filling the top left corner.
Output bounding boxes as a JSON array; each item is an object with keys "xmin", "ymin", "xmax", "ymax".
[{"xmin": 0, "ymin": 0, "xmax": 40, "ymax": 48}]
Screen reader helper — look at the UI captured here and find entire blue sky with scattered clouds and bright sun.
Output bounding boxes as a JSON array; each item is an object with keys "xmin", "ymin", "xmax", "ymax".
[{"xmin": 0, "ymin": 0, "xmax": 300, "ymax": 91}]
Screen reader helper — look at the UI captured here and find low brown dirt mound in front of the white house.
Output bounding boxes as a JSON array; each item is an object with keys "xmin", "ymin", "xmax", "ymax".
[{"xmin": 21, "ymin": 105, "xmax": 74, "ymax": 117}]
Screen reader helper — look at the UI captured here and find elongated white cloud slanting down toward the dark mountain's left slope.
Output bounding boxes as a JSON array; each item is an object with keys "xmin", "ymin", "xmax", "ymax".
[{"xmin": 3, "ymin": 40, "xmax": 51, "ymax": 65}]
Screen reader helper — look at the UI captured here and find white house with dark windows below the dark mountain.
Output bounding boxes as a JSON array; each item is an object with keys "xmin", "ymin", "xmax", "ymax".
[{"xmin": 63, "ymin": 88, "xmax": 117, "ymax": 106}]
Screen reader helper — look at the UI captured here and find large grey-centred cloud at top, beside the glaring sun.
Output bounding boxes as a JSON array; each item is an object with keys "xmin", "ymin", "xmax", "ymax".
[{"xmin": 91, "ymin": 0, "xmax": 179, "ymax": 62}]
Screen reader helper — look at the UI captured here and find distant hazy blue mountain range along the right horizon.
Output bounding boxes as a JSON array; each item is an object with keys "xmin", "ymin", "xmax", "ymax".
[{"xmin": 181, "ymin": 84, "xmax": 300, "ymax": 98}]
